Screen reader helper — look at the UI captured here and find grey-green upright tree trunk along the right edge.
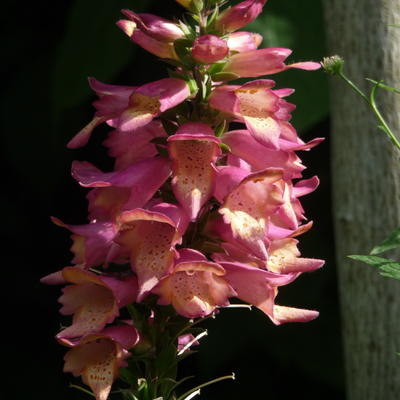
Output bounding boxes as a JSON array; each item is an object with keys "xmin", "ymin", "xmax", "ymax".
[{"xmin": 325, "ymin": 0, "xmax": 400, "ymax": 400}]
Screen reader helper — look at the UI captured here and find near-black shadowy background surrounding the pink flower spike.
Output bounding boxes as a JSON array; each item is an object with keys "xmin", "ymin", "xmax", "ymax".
[{"xmin": 0, "ymin": 0, "xmax": 344, "ymax": 400}]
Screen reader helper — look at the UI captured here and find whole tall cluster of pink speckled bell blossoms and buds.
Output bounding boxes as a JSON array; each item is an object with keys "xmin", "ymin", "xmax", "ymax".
[{"xmin": 43, "ymin": 0, "xmax": 323, "ymax": 400}]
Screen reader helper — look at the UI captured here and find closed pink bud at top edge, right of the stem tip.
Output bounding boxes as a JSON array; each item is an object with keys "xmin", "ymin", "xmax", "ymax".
[{"xmin": 215, "ymin": 0, "xmax": 267, "ymax": 32}]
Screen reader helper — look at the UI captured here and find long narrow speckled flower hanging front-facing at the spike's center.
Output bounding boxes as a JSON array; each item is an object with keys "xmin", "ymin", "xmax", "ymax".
[{"xmin": 168, "ymin": 122, "xmax": 221, "ymax": 221}]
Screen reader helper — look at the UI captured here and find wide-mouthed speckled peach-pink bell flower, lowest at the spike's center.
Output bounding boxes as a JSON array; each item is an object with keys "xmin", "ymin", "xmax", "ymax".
[{"xmin": 153, "ymin": 249, "xmax": 236, "ymax": 318}]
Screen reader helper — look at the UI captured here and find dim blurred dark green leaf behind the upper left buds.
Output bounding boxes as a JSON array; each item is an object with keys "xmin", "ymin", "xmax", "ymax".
[{"xmin": 52, "ymin": 0, "xmax": 148, "ymax": 115}]
